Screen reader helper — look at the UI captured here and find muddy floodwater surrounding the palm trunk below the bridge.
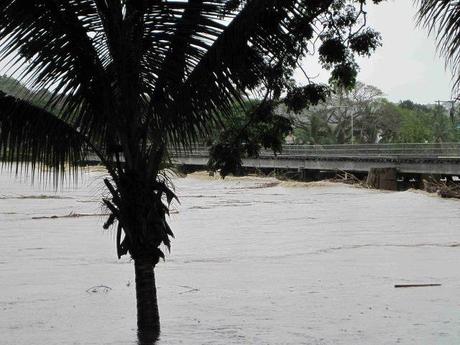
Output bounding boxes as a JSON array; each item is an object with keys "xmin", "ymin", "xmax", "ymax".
[{"xmin": 0, "ymin": 170, "xmax": 460, "ymax": 345}]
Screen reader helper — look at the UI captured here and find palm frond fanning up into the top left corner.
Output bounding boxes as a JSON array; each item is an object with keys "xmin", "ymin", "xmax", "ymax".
[{"xmin": 0, "ymin": 0, "xmax": 111, "ymax": 138}]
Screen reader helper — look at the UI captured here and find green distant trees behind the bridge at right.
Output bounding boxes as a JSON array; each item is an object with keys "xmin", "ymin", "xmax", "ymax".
[{"xmin": 288, "ymin": 82, "xmax": 460, "ymax": 145}]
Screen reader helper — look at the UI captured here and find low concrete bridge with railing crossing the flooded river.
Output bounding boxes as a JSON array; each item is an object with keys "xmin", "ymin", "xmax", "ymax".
[{"xmin": 173, "ymin": 143, "xmax": 460, "ymax": 176}]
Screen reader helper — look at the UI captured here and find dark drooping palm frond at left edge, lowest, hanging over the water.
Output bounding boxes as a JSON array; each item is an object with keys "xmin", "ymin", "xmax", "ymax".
[{"xmin": 0, "ymin": 91, "xmax": 85, "ymax": 183}]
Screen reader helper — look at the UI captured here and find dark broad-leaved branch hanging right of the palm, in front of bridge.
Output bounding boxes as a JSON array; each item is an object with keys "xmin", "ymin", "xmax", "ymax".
[{"xmin": 204, "ymin": 1, "xmax": 381, "ymax": 177}]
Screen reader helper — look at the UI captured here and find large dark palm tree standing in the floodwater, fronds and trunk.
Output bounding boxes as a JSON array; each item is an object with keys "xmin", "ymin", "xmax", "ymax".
[{"xmin": 0, "ymin": 0, "xmax": 379, "ymax": 339}]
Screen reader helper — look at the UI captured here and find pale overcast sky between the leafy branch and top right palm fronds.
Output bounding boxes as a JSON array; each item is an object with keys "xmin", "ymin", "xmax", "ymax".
[{"xmin": 298, "ymin": 0, "xmax": 452, "ymax": 103}]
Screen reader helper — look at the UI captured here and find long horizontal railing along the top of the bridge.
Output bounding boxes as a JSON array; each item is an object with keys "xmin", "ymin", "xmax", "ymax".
[{"xmin": 175, "ymin": 143, "xmax": 460, "ymax": 158}]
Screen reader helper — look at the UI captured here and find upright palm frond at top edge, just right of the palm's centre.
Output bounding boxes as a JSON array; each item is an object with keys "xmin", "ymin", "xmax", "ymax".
[{"xmin": 143, "ymin": 0, "xmax": 225, "ymax": 89}]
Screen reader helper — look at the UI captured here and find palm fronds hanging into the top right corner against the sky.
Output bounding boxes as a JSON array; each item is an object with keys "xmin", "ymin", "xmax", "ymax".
[{"xmin": 417, "ymin": 0, "xmax": 460, "ymax": 97}]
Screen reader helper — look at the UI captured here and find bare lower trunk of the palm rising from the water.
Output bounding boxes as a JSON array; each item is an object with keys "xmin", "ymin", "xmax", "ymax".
[{"xmin": 134, "ymin": 258, "xmax": 160, "ymax": 341}]
